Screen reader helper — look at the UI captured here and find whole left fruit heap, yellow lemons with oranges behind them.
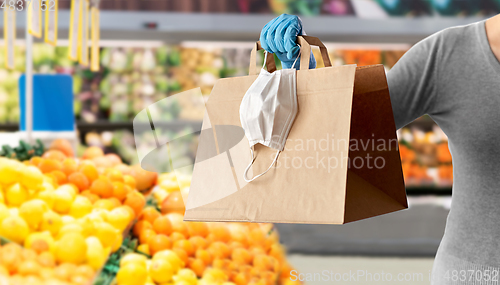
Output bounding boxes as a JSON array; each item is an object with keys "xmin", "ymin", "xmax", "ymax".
[{"xmin": 0, "ymin": 141, "xmax": 157, "ymax": 284}]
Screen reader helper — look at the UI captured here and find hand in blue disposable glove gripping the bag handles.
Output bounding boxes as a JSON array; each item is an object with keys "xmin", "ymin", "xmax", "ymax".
[{"xmin": 260, "ymin": 14, "xmax": 316, "ymax": 69}]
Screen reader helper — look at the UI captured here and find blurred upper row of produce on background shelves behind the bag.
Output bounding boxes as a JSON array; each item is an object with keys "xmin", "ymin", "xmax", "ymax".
[{"xmin": 0, "ymin": 42, "xmax": 404, "ymax": 124}]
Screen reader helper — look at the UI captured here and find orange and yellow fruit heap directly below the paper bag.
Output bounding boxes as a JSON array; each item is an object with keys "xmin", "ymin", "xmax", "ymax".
[{"xmin": 116, "ymin": 173, "xmax": 300, "ymax": 285}]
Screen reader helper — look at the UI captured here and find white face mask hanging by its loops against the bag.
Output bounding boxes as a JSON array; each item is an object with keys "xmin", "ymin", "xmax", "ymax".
[{"xmin": 240, "ymin": 52, "xmax": 298, "ymax": 182}]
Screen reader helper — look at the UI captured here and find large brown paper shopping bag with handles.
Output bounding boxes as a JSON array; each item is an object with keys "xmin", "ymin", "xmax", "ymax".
[{"xmin": 184, "ymin": 36, "xmax": 408, "ymax": 224}]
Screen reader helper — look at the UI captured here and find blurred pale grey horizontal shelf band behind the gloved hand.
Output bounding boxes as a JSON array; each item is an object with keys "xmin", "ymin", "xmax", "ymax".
[{"xmin": 0, "ymin": 10, "xmax": 490, "ymax": 43}]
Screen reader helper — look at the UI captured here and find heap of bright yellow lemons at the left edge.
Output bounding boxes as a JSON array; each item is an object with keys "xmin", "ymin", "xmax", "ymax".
[{"xmin": 0, "ymin": 158, "xmax": 140, "ymax": 284}]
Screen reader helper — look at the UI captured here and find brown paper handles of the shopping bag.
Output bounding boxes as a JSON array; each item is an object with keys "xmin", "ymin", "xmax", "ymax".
[{"xmin": 248, "ymin": 36, "xmax": 332, "ymax": 75}]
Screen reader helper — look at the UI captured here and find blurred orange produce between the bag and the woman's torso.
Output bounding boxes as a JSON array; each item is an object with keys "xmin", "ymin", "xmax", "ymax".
[{"xmin": 399, "ymin": 122, "xmax": 453, "ymax": 187}]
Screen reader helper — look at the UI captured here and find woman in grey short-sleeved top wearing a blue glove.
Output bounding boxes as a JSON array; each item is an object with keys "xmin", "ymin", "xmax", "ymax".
[{"xmin": 260, "ymin": 14, "xmax": 500, "ymax": 285}]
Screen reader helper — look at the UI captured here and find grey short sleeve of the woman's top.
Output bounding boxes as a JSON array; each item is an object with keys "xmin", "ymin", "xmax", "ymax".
[{"xmin": 387, "ymin": 32, "xmax": 442, "ymax": 129}]
